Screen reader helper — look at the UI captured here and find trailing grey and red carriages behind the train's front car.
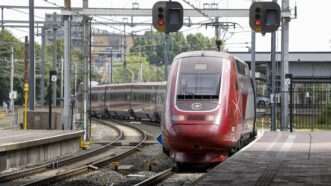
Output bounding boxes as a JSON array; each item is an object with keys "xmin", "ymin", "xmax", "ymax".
[{"xmin": 91, "ymin": 82, "xmax": 166, "ymax": 122}]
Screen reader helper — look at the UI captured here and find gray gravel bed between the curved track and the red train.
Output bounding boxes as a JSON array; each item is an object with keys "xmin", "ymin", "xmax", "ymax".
[{"xmin": 53, "ymin": 124, "xmax": 174, "ymax": 186}]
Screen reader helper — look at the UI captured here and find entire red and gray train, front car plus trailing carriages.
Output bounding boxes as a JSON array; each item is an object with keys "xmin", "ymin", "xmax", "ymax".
[{"xmin": 87, "ymin": 51, "xmax": 256, "ymax": 164}]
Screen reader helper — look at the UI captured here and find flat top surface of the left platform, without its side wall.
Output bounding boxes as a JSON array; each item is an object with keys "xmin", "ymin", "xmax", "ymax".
[{"xmin": 0, "ymin": 130, "xmax": 83, "ymax": 152}]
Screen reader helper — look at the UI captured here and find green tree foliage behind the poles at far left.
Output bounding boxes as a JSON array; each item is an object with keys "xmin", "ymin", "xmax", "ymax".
[{"xmin": 0, "ymin": 30, "xmax": 91, "ymax": 105}]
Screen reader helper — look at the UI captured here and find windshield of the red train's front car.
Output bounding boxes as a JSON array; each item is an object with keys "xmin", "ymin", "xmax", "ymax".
[{"xmin": 177, "ymin": 57, "xmax": 222, "ymax": 99}]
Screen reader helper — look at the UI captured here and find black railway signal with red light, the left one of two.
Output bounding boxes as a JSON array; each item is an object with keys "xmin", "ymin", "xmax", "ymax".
[{"xmin": 152, "ymin": 1, "xmax": 184, "ymax": 33}]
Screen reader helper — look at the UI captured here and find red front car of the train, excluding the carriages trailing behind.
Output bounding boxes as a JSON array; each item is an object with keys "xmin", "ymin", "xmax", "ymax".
[{"xmin": 162, "ymin": 51, "xmax": 255, "ymax": 163}]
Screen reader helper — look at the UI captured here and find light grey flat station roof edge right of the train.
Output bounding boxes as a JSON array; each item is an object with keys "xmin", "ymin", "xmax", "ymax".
[{"xmin": 229, "ymin": 51, "xmax": 331, "ymax": 63}]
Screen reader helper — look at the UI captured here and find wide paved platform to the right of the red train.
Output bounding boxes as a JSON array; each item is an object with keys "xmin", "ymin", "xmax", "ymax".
[{"xmin": 196, "ymin": 132, "xmax": 331, "ymax": 186}]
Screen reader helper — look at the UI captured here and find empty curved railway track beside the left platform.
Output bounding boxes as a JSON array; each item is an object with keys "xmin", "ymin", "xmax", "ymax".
[{"xmin": 0, "ymin": 120, "xmax": 152, "ymax": 186}]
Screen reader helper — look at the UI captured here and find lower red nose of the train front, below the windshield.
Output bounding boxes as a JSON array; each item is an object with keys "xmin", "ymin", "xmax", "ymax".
[{"xmin": 167, "ymin": 120, "xmax": 227, "ymax": 163}]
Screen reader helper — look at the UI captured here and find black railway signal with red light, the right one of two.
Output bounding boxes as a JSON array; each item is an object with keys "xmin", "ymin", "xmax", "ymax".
[{"xmin": 249, "ymin": 2, "xmax": 281, "ymax": 34}]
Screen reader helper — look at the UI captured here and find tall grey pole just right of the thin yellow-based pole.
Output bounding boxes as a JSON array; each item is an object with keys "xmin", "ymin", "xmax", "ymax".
[{"xmin": 29, "ymin": 0, "xmax": 35, "ymax": 111}]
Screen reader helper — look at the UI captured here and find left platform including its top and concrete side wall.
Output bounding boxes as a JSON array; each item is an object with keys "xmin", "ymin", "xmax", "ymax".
[{"xmin": 0, "ymin": 130, "xmax": 83, "ymax": 173}]
